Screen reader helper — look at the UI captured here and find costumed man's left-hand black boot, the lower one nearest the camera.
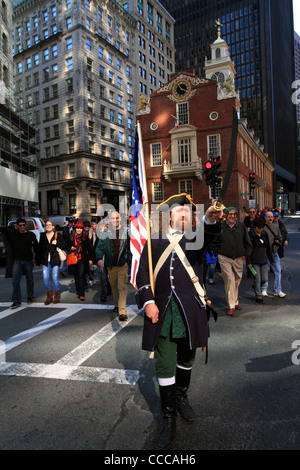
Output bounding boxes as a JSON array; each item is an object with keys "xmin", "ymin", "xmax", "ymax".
[{"xmin": 157, "ymin": 384, "xmax": 176, "ymax": 449}]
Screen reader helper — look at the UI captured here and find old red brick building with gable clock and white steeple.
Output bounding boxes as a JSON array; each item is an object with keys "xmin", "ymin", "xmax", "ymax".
[{"xmin": 137, "ymin": 35, "xmax": 274, "ymax": 216}]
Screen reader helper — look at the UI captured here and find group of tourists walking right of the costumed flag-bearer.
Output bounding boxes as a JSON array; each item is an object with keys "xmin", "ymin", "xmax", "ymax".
[{"xmin": 206, "ymin": 207, "xmax": 289, "ymax": 308}]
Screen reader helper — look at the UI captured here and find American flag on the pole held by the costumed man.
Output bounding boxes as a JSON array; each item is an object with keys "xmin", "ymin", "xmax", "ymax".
[{"xmin": 130, "ymin": 124, "xmax": 147, "ymax": 289}]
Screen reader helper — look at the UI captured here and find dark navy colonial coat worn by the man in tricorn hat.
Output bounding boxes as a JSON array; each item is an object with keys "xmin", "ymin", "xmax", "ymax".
[{"xmin": 136, "ymin": 224, "xmax": 219, "ymax": 351}]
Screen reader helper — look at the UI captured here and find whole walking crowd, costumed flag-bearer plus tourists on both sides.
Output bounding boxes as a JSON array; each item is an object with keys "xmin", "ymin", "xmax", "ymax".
[{"xmin": 0, "ymin": 193, "xmax": 288, "ymax": 449}]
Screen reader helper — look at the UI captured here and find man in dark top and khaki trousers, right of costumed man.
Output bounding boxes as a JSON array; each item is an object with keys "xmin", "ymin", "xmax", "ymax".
[{"xmin": 218, "ymin": 207, "xmax": 252, "ymax": 316}]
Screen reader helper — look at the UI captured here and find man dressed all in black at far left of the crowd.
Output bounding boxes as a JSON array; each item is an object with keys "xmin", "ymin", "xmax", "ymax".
[{"xmin": 2, "ymin": 218, "xmax": 40, "ymax": 309}]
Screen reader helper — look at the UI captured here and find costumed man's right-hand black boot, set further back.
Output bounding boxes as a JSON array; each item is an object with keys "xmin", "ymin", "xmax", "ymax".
[{"xmin": 176, "ymin": 367, "xmax": 195, "ymax": 422}]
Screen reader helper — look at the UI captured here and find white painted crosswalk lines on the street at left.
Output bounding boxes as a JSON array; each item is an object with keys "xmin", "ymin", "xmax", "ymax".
[{"xmin": 0, "ymin": 303, "xmax": 139, "ymax": 385}]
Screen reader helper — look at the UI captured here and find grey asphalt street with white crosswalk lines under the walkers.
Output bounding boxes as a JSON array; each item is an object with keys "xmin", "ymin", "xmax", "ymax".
[{"xmin": 0, "ymin": 218, "xmax": 300, "ymax": 455}]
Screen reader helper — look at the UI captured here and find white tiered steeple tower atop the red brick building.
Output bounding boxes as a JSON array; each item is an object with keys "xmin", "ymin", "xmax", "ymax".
[{"xmin": 204, "ymin": 20, "xmax": 239, "ymax": 100}]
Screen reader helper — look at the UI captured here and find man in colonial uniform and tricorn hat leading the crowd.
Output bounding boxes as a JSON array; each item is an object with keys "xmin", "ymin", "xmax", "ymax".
[{"xmin": 136, "ymin": 194, "xmax": 221, "ymax": 448}]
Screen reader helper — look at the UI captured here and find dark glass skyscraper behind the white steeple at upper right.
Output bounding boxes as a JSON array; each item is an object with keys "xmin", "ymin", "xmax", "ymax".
[{"xmin": 161, "ymin": 0, "xmax": 299, "ymax": 206}]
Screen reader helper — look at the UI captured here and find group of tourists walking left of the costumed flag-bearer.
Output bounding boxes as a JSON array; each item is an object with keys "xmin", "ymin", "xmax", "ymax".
[{"xmin": 2, "ymin": 211, "xmax": 131, "ymax": 321}]
